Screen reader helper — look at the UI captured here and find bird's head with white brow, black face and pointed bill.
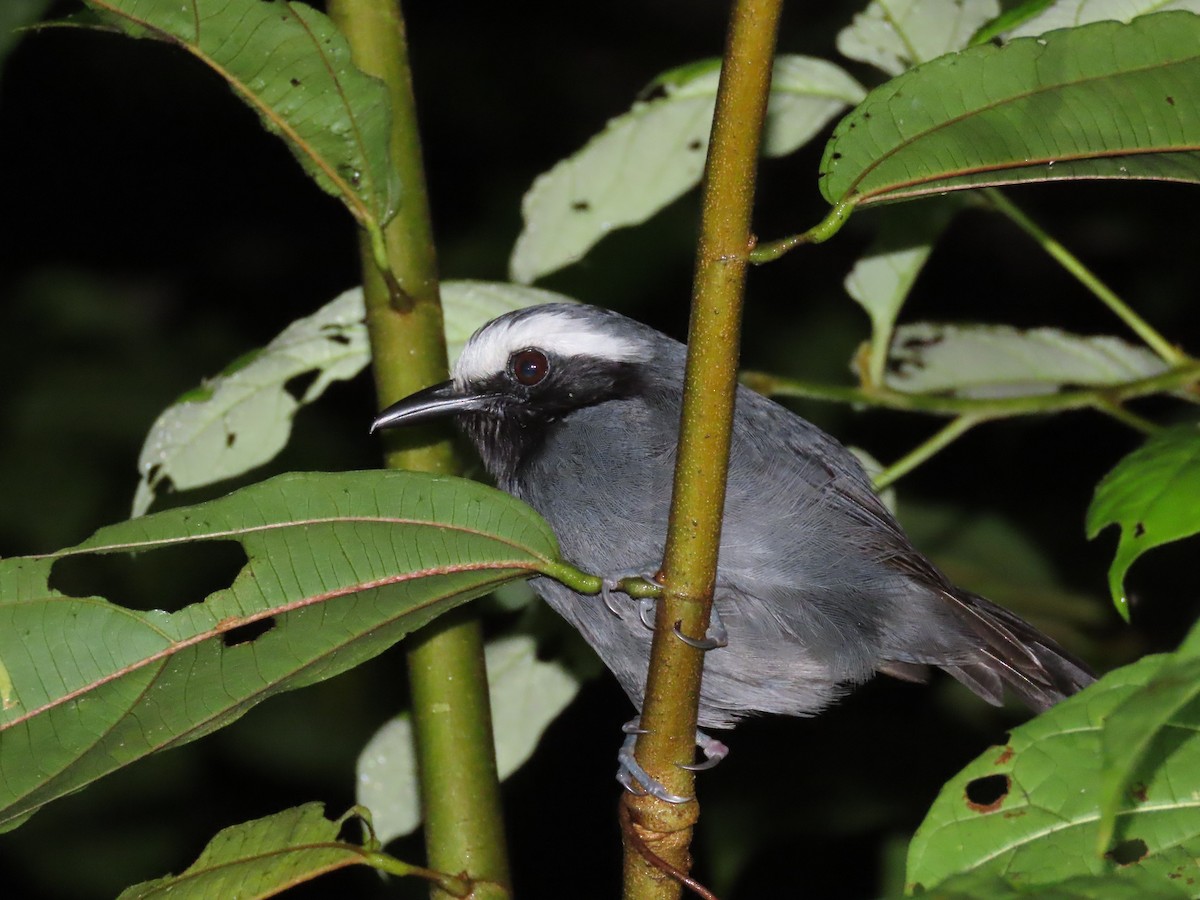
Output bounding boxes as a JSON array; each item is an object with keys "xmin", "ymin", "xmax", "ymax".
[{"xmin": 372, "ymin": 304, "xmax": 682, "ymax": 482}]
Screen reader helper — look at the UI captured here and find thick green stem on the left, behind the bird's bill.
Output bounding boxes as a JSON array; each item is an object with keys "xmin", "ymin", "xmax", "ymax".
[{"xmin": 329, "ymin": 0, "xmax": 509, "ymax": 898}]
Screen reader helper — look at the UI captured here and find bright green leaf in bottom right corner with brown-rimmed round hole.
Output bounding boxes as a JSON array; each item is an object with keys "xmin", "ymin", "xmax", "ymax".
[{"xmin": 907, "ymin": 656, "xmax": 1200, "ymax": 893}]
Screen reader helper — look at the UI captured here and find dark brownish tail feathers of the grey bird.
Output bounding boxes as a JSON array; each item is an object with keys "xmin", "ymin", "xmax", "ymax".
[{"xmin": 942, "ymin": 592, "xmax": 1096, "ymax": 713}]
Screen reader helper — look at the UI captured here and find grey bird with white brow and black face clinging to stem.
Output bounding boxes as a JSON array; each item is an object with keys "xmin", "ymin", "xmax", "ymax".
[{"xmin": 372, "ymin": 302, "xmax": 1094, "ymax": 799}]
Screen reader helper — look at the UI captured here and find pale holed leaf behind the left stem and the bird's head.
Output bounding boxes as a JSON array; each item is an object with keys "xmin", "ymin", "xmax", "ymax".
[{"xmin": 133, "ymin": 281, "xmax": 570, "ymax": 516}]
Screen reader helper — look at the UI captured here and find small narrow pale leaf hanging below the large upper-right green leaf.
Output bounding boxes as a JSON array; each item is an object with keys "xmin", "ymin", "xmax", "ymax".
[{"xmin": 845, "ymin": 202, "xmax": 961, "ymax": 386}]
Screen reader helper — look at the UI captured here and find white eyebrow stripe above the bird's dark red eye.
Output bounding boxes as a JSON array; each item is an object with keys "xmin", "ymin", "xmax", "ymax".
[{"xmin": 454, "ymin": 312, "xmax": 641, "ymax": 384}]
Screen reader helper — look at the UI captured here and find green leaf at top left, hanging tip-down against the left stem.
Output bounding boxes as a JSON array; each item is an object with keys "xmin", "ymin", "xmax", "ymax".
[{"xmin": 84, "ymin": 0, "xmax": 401, "ymax": 236}]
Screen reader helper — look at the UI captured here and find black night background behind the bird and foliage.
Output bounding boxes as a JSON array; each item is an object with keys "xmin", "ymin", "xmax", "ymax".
[{"xmin": 0, "ymin": 0, "xmax": 1198, "ymax": 898}]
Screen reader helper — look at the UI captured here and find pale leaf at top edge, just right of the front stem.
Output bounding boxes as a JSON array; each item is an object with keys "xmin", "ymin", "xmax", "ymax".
[{"xmin": 838, "ymin": 0, "xmax": 1000, "ymax": 76}]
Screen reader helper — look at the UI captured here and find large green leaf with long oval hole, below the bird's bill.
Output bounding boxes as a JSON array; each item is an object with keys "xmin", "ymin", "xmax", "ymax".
[{"xmin": 0, "ymin": 472, "xmax": 569, "ymax": 830}]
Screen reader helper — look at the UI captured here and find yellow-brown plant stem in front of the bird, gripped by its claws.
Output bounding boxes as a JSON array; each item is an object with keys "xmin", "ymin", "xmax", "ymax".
[{"xmin": 623, "ymin": 0, "xmax": 782, "ymax": 898}]
